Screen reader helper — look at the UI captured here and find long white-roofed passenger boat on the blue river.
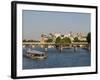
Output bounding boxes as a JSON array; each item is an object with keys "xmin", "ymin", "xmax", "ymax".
[{"xmin": 24, "ymin": 49, "xmax": 47, "ymax": 60}]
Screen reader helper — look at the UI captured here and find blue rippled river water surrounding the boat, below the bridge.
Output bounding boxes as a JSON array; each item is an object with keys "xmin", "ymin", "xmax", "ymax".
[{"xmin": 23, "ymin": 48, "xmax": 91, "ymax": 69}]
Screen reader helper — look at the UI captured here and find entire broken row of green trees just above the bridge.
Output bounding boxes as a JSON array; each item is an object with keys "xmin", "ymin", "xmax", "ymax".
[{"xmin": 23, "ymin": 32, "xmax": 91, "ymax": 44}]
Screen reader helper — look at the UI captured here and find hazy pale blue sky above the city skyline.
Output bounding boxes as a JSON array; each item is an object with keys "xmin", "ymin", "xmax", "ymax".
[{"xmin": 22, "ymin": 10, "xmax": 91, "ymax": 40}]
